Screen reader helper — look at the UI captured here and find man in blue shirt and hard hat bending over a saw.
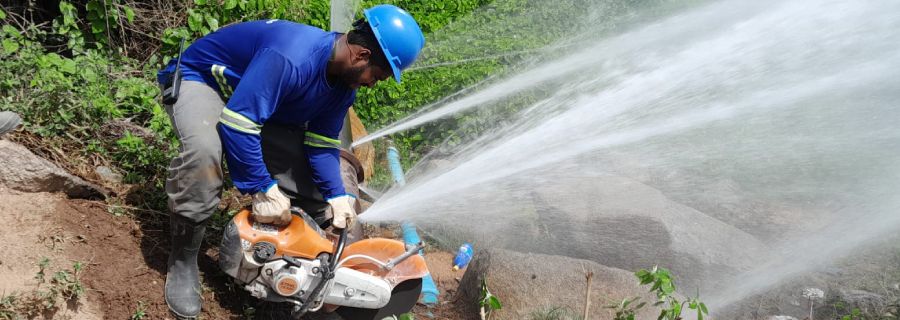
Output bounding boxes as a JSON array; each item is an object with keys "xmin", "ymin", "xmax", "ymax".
[{"xmin": 159, "ymin": 5, "xmax": 425, "ymax": 318}]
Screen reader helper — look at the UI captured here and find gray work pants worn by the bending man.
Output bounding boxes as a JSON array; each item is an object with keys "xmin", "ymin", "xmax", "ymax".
[{"xmin": 166, "ymin": 81, "xmax": 328, "ymax": 222}]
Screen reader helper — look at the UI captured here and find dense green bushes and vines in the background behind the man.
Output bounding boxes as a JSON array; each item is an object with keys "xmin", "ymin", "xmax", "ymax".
[{"xmin": 0, "ymin": 0, "xmax": 652, "ymax": 212}]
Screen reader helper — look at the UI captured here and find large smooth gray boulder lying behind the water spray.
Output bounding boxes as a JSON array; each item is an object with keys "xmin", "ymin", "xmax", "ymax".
[{"xmin": 416, "ymin": 171, "xmax": 768, "ymax": 292}]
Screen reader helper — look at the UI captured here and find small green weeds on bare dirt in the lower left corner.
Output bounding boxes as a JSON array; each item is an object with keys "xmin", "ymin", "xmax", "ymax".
[{"xmin": 0, "ymin": 258, "xmax": 85, "ymax": 320}]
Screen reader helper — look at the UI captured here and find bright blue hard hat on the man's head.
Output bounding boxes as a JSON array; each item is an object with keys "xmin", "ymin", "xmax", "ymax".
[{"xmin": 363, "ymin": 4, "xmax": 425, "ymax": 83}]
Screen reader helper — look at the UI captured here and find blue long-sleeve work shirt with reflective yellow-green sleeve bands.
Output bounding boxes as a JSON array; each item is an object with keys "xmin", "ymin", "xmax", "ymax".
[{"xmin": 158, "ymin": 20, "xmax": 356, "ymax": 199}]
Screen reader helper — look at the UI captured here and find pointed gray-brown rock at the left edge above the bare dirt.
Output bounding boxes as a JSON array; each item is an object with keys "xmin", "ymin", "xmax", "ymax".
[{"xmin": 0, "ymin": 140, "xmax": 103, "ymax": 198}]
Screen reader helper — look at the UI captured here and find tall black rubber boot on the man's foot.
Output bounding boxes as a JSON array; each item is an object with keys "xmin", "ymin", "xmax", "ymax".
[{"xmin": 166, "ymin": 215, "xmax": 206, "ymax": 319}]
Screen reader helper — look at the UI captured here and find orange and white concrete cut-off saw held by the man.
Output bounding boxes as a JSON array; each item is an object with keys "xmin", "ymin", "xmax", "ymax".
[{"xmin": 219, "ymin": 209, "xmax": 428, "ymax": 320}]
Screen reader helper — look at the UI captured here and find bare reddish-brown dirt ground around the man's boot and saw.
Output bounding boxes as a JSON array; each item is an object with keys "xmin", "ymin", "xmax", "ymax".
[{"xmin": 0, "ymin": 190, "xmax": 477, "ymax": 320}]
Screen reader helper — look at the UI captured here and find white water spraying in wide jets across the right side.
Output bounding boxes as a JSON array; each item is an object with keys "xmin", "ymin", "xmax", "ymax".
[{"xmin": 363, "ymin": 0, "xmax": 900, "ymax": 316}]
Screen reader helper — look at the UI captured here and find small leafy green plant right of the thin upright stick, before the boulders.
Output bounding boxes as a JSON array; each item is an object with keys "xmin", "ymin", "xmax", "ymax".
[{"xmin": 634, "ymin": 266, "xmax": 709, "ymax": 320}]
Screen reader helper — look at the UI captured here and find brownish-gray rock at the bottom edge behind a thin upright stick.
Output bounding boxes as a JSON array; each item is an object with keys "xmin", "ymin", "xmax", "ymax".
[{"xmin": 459, "ymin": 249, "xmax": 655, "ymax": 319}]
